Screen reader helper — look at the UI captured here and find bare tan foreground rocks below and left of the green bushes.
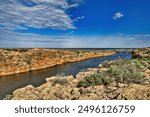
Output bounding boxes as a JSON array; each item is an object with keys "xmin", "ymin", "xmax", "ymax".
[{"xmin": 13, "ymin": 61, "xmax": 150, "ymax": 100}]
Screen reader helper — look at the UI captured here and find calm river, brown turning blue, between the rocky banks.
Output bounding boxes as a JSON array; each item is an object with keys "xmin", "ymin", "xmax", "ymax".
[{"xmin": 0, "ymin": 52, "xmax": 132, "ymax": 99}]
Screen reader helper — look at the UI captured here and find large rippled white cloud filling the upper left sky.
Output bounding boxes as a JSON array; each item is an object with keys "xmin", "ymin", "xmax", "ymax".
[{"xmin": 0, "ymin": 0, "xmax": 82, "ymax": 31}]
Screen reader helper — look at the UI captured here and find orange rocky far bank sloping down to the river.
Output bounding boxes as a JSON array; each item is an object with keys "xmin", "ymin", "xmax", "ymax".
[{"xmin": 0, "ymin": 49, "xmax": 115, "ymax": 75}]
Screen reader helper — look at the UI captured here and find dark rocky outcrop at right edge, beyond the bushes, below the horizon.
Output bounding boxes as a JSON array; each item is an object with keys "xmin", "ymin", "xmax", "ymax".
[{"xmin": 132, "ymin": 48, "xmax": 150, "ymax": 58}]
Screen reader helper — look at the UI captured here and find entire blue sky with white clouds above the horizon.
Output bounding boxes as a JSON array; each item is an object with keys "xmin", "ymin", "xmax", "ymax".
[{"xmin": 0, "ymin": 0, "xmax": 150, "ymax": 48}]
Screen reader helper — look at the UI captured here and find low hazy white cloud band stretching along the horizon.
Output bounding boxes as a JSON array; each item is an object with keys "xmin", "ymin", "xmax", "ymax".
[{"xmin": 0, "ymin": 31, "xmax": 150, "ymax": 48}]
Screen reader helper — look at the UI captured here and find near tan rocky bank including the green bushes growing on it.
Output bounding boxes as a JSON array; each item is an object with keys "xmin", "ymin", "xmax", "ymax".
[{"xmin": 12, "ymin": 55, "xmax": 150, "ymax": 100}]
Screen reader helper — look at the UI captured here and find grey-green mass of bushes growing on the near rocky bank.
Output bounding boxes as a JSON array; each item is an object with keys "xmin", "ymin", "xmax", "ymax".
[{"xmin": 78, "ymin": 59, "xmax": 149, "ymax": 87}]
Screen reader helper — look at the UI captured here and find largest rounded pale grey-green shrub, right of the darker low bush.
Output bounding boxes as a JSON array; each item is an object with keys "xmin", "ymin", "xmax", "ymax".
[{"xmin": 106, "ymin": 60, "xmax": 145, "ymax": 83}]
